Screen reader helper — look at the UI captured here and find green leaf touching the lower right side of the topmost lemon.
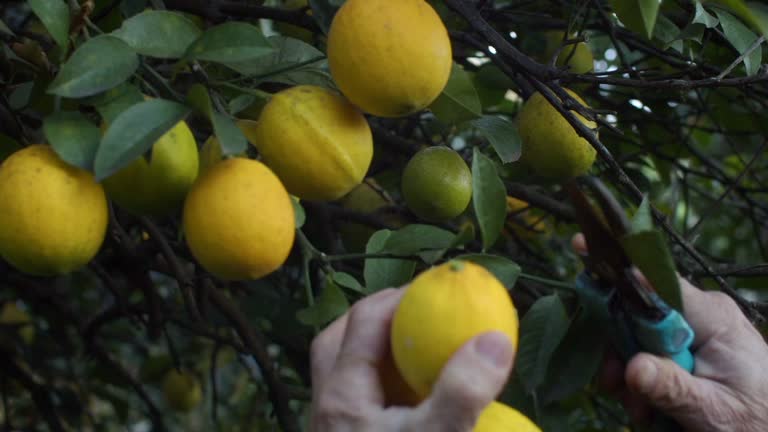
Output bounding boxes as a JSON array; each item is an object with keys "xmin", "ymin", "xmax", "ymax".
[{"xmin": 429, "ymin": 63, "xmax": 482, "ymax": 124}]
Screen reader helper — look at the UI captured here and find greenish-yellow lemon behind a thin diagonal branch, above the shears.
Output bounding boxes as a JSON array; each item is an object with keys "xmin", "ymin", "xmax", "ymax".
[{"xmin": 517, "ymin": 89, "xmax": 597, "ymax": 180}]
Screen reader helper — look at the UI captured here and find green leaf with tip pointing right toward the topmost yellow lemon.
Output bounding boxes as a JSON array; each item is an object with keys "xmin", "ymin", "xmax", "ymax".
[{"xmin": 186, "ymin": 21, "xmax": 273, "ymax": 63}]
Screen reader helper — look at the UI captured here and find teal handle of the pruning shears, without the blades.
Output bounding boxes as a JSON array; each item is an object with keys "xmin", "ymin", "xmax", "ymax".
[{"xmin": 576, "ymin": 273, "xmax": 694, "ymax": 372}]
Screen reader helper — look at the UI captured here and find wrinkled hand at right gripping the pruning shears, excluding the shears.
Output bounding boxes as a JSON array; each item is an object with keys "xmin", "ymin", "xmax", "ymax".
[{"xmin": 573, "ymin": 235, "xmax": 768, "ymax": 432}]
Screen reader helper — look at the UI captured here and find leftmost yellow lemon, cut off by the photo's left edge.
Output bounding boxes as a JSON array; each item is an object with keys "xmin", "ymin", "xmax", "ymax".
[{"xmin": 0, "ymin": 145, "xmax": 108, "ymax": 276}]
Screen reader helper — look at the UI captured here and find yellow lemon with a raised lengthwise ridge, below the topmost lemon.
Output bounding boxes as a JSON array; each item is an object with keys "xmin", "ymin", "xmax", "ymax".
[{"xmin": 250, "ymin": 86, "xmax": 373, "ymax": 201}]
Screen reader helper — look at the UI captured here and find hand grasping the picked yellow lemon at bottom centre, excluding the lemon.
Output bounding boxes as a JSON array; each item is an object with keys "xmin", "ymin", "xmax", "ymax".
[{"xmin": 311, "ymin": 289, "xmax": 514, "ymax": 432}]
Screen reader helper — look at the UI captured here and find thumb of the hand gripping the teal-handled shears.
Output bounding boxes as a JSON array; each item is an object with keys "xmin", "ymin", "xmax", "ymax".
[{"xmin": 625, "ymin": 353, "xmax": 712, "ymax": 423}]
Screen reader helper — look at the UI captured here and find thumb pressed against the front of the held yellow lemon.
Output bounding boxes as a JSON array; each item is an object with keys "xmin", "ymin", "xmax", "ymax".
[{"xmin": 415, "ymin": 332, "xmax": 514, "ymax": 431}]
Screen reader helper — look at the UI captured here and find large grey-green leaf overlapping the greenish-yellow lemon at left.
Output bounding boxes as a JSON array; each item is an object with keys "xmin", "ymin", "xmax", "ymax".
[{"xmin": 94, "ymin": 99, "xmax": 189, "ymax": 181}]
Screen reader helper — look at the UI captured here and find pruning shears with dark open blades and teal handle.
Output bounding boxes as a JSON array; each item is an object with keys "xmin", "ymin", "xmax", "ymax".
[{"xmin": 566, "ymin": 177, "xmax": 694, "ymax": 431}]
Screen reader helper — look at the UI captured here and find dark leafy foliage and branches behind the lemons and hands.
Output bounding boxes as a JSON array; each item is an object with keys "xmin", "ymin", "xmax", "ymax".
[{"xmin": 0, "ymin": 0, "xmax": 768, "ymax": 432}]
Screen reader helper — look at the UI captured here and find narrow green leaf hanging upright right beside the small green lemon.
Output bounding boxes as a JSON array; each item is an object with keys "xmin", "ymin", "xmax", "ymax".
[{"xmin": 472, "ymin": 147, "xmax": 507, "ymax": 250}]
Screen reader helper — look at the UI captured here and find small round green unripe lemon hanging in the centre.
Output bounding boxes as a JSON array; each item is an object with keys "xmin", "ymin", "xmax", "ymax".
[{"xmin": 401, "ymin": 147, "xmax": 472, "ymax": 222}]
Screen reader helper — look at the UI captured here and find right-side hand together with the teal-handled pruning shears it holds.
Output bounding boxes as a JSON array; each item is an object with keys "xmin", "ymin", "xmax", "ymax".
[{"xmin": 568, "ymin": 177, "xmax": 768, "ymax": 432}]
